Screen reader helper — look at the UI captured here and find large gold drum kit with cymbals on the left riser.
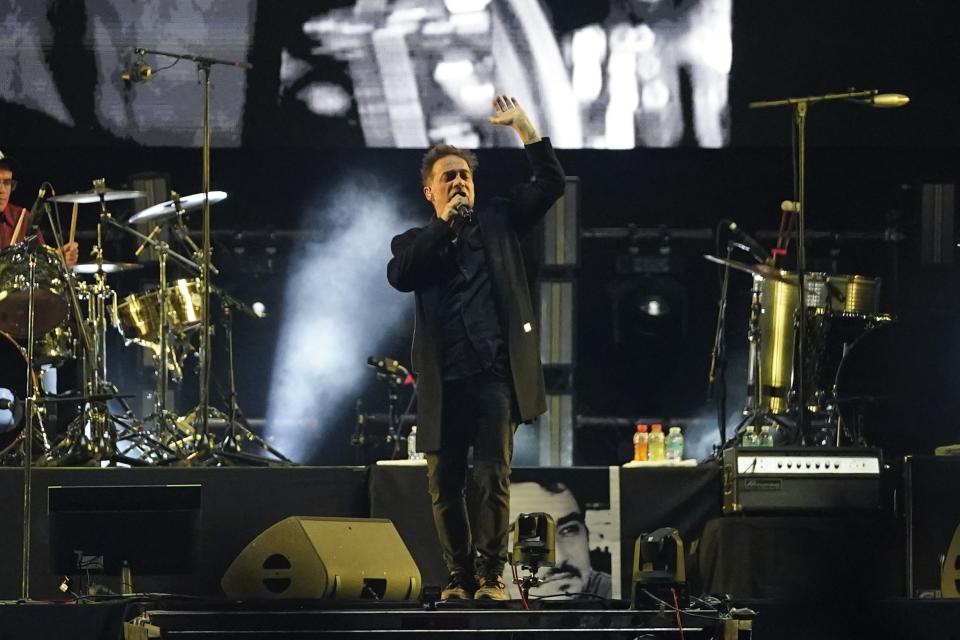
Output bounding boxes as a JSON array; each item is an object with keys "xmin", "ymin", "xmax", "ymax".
[{"xmin": 0, "ymin": 180, "xmax": 289, "ymax": 466}]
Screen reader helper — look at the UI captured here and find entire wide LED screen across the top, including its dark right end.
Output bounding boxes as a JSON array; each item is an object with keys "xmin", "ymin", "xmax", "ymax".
[{"xmin": 0, "ymin": 0, "xmax": 960, "ymax": 149}]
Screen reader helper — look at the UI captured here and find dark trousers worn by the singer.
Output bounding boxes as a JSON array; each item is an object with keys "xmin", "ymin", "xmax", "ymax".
[{"xmin": 427, "ymin": 372, "xmax": 516, "ymax": 575}]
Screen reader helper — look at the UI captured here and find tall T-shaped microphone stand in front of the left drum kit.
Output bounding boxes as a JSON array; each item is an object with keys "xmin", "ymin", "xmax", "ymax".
[{"xmin": 136, "ymin": 47, "xmax": 253, "ymax": 455}]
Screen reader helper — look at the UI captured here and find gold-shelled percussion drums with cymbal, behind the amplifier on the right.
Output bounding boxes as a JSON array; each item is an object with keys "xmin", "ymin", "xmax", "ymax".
[{"xmin": 704, "ymin": 250, "xmax": 893, "ymax": 446}]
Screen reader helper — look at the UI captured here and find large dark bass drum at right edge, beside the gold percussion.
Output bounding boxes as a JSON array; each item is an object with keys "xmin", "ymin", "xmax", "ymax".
[{"xmin": 836, "ymin": 318, "xmax": 960, "ymax": 460}]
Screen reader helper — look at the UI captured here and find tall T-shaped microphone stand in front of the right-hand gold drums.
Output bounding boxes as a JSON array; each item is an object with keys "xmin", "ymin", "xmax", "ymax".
[{"xmin": 749, "ymin": 89, "xmax": 880, "ymax": 444}]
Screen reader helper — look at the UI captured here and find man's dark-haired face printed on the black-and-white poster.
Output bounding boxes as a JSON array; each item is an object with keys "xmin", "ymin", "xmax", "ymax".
[{"xmin": 511, "ymin": 482, "xmax": 592, "ymax": 596}]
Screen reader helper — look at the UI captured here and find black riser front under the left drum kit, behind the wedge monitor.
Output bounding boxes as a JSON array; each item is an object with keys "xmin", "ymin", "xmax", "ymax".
[{"xmin": 0, "ymin": 467, "xmax": 369, "ymax": 599}]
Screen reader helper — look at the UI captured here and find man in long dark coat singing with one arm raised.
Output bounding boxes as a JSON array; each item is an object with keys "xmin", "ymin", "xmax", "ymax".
[{"xmin": 387, "ymin": 96, "xmax": 565, "ymax": 600}]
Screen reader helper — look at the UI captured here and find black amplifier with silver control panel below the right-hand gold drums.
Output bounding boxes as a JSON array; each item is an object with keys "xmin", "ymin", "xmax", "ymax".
[{"xmin": 723, "ymin": 447, "xmax": 881, "ymax": 515}]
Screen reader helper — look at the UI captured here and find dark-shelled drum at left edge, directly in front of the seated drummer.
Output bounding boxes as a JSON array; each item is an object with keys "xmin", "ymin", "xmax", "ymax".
[{"xmin": 0, "ymin": 242, "xmax": 68, "ymax": 339}]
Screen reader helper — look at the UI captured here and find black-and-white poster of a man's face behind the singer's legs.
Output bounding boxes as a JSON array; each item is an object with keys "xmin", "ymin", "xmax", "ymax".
[{"xmin": 504, "ymin": 467, "xmax": 620, "ymax": 598}]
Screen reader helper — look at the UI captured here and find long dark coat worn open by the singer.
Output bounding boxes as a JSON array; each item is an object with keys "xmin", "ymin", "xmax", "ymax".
[{"xmin": 387, "ymin": 138, "xmax": 565, "ymax": 451}]
